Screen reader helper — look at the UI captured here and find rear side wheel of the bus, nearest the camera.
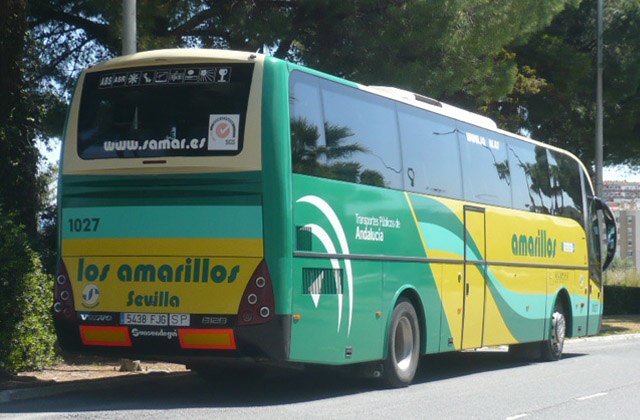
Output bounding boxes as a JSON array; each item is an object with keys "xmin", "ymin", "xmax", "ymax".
[{"xmin": 383, "ymin": 299, "xmax": 420, "ymax": 388}]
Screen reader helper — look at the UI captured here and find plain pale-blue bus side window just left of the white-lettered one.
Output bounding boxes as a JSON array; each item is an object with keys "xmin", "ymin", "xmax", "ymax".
[{"xmin": 398, "ymin": 104, "xmax": 462, "ymax": 198}]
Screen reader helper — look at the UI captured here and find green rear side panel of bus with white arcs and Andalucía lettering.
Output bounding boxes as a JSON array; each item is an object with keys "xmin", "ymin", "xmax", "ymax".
[{"xmin": 291, "ymin": 174, "xmax": 424, "ymax": 363}]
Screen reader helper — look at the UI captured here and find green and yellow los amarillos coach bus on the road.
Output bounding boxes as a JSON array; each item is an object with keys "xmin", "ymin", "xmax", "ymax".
[{"xmin": 53, "ymin": 49, "xmax": 616, "ymax": 387}]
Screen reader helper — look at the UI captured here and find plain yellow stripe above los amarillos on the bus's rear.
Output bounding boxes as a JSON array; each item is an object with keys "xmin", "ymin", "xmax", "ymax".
[{"xmin": 62, "ymin": 238, "xmax": 264, "ymax": 257}]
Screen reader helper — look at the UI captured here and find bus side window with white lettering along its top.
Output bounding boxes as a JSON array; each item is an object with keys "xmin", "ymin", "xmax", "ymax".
[{"xmin": 458, "ymin": 124, "xmax": 511, "ymax": 207}]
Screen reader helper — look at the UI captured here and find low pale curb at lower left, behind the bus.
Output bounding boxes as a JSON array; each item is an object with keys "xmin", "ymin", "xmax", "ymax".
[{"xmin": 0, "ymin": 372, "xmax": 191, "ymax": 404}]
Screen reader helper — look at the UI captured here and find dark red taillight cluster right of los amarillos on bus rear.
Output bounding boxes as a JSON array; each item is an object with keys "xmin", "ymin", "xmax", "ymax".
[{"xmin": 238, "ymin": 261, "xmax": 275, "ymax": 325}]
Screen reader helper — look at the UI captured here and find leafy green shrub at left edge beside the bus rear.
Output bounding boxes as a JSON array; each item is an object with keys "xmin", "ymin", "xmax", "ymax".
[{"xmin": 0, "ymin": 212, "xmax": 56, "ymax": 373}]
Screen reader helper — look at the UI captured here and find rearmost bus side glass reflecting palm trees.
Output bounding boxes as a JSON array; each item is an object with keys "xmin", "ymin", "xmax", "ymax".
[{"xmin": 290, "ymin": 72, "xmax": 401, "ymax": 188}]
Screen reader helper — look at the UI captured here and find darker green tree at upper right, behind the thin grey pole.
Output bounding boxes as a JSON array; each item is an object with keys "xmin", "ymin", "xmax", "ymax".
[{"xmin": 486, "ymin": 0, "xmax": 640, "ymax": 169}]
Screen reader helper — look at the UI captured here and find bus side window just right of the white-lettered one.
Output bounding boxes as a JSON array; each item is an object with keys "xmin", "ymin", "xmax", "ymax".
[{"xmin": 508, "ymin": 139, "xmax": 552, "ymax": 214}]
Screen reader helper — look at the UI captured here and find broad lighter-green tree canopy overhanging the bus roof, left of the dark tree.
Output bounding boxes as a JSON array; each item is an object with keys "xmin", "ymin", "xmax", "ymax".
[{"xmin": 30, "ymin": 0, "xmax": 577, "ymax": 103}]
